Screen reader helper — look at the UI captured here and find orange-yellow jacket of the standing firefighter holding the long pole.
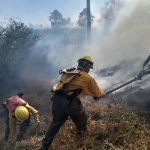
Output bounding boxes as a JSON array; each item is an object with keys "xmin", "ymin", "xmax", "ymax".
[{"xmin": 60, "ymin": 69, "xmax": 105, "ymax": 97}]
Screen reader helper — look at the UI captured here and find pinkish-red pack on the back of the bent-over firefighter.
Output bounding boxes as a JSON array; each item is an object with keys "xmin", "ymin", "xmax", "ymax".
[{"xmin": 6, "ymin": 95, "xmax": 27, "ymax": 111}]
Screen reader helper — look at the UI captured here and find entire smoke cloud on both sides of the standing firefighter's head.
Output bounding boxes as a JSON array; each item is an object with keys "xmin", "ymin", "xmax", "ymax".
[{"xmin": 19, "ymin": 0, "xmax": 150, "ymax": 94}]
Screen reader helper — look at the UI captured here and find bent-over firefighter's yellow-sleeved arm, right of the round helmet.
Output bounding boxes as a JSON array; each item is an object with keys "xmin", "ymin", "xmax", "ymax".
[{"xmin": 26, "ymin": 104, "xmax": 40, "ymax": 125}]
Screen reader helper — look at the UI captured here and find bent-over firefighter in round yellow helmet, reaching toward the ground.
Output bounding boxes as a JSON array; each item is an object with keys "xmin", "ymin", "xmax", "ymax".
[{"xmin": 6, "ymin": 95, "xmax": 40, "ymax": 143}]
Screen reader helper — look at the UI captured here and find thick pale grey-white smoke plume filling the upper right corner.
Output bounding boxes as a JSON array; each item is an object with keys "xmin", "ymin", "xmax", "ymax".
[{"xmin": 93, "ymin": 0, "xmax": 150, "ymax": 67}]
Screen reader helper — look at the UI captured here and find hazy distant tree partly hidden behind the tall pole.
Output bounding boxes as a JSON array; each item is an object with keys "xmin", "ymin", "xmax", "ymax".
[{"xmin": 77, "ymin": 8, "xmax": 94, "ymax": 27}]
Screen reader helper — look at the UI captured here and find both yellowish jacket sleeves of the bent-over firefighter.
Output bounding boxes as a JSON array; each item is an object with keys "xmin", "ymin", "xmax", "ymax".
[{"xmin": 9, "ymin": 103, "xmax": 40, "ymax": 142}]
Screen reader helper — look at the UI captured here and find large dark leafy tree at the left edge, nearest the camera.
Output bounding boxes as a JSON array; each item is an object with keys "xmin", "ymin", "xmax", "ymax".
[{"xmin": 0, "ymin": 19, "xmax": 39, "ymax": 95}]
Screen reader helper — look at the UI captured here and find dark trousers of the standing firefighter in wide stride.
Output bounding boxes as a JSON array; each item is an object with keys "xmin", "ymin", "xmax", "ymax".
[{"xmin": 41, "ymin": 95, "xmax": 87, "ymax": 150}]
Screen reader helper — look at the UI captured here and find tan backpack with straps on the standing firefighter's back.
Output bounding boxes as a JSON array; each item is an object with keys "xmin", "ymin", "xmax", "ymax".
[{"xmin": 52, "ymin": 68, "xmax": 80, "ymax": 92}]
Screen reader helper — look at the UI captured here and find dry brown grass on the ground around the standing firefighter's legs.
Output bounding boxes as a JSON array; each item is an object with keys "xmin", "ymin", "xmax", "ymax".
[{"xmin": 0, "ymin": 102, "xmax": 150, "ymax": 150}]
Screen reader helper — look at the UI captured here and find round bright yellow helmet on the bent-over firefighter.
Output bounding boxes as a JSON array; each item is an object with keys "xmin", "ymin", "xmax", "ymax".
[{"xmin": 15, "ymin": 106, "xmax": 29, "ymax": 121}]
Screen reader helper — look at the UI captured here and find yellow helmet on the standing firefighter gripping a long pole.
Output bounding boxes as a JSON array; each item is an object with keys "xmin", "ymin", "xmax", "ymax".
[{"xmin": 78, "ymin": 55, "xmax": 94, "ymax": 69}]
